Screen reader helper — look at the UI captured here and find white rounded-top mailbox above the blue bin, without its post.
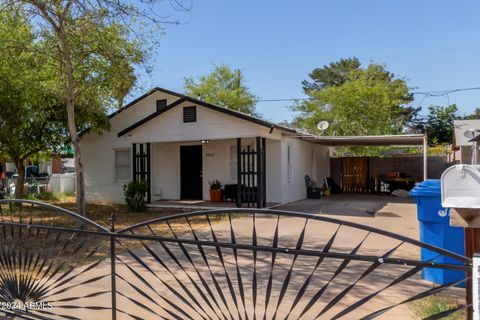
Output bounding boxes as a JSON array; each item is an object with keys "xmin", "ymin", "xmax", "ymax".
[{"xmin": 441, "ymin": 164, "xmax": 480, "ymax": 209}]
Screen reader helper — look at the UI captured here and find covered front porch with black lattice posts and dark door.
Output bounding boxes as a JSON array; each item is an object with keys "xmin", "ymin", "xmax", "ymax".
[{"xmin": 132, "ymin": 137, "xmax": 281, "ymax": 209}]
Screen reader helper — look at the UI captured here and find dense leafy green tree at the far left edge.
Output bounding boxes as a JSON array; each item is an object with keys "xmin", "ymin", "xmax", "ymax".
[{"xmin": 0, "ymin": 12, "xmax": 67, "ymax": 198}]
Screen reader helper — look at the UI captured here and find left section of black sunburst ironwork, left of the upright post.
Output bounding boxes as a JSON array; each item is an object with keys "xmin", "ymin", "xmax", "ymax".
[{"xmin": 0, "ymin": 200, "xmax": 111, "ymax": 319}]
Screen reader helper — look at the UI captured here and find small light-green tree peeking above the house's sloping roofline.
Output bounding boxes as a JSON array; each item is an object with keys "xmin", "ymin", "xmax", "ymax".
[{"xmin": 185, "ymin": 65, "xmax": 257, "ymax": 115}]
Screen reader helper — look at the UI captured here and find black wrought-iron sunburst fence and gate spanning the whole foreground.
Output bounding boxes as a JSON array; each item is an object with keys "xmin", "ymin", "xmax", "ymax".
[{"xmin": 0, "ymin": 200, "xmax": 471, "ymax": 320}]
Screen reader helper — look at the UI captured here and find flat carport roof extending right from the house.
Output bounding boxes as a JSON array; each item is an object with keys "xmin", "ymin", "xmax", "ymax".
[{"xmin": 299, "ymin": 134, "xmax": 425, "ymax": 147}]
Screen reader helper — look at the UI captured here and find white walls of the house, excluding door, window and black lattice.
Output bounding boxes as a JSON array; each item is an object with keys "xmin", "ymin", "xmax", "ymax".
[{"xmin": 81, "ymin": 92, "xmax": 330, "ymax": 203}]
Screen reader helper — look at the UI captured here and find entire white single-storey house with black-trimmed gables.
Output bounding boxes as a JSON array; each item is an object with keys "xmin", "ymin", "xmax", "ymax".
[{"xmin": 81, "ymin": 88, "xmax": 330, "ymax": 206}]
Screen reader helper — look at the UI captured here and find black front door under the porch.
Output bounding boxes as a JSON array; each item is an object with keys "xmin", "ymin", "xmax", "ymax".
[{"xmin": 180, "ymin": 145, "xmax": 203, "ymax": 200}]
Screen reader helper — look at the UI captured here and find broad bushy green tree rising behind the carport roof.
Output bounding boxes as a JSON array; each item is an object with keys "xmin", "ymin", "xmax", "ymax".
[{"xmin": 293, "ymin": 60, "xmax": 413, "ymax": 141}]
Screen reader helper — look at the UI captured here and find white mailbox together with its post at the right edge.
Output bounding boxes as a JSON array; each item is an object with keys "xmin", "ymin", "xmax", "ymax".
[{"xmin": 441, "ymin": 164, "xmax": 480, "ymax": 320}]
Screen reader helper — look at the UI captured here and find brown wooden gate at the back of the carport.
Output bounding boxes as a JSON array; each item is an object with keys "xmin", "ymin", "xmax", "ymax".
[{"xmin": 341, "ymin": 157, "xmax": 369, "ymax": 192}]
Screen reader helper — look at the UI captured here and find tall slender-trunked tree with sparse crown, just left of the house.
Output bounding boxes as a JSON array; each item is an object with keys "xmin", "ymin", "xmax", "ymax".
[{"xmin": 0, "ymin": 0, "xmax": 178, "ymax": 215}]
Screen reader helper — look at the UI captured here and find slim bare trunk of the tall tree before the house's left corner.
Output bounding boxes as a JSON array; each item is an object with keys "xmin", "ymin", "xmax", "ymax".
[{"xmin": 59, "ymin": 29, "xmax": 87, "ymax": 216}]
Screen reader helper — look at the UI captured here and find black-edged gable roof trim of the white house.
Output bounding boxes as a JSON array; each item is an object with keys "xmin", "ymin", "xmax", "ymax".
[{"xmin": 118, "ymin": 88, "xmax": 297, "ymax": 137}]
